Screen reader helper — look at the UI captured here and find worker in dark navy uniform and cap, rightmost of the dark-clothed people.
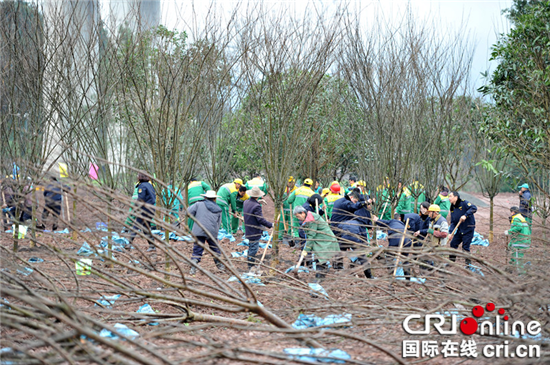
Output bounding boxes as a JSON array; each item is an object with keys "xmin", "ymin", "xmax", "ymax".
[{"xmin": 449, "ymin": 191, "xmax": 477, "ymax": 267}]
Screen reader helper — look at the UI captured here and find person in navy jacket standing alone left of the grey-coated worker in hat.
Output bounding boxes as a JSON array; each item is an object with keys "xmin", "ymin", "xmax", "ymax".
[{"xmin": 130, "ymin": 172, "xmax": 157, "ymax": 251}]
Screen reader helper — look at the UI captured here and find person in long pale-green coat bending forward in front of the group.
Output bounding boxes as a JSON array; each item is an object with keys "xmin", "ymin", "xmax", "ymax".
[{"xmin": 293, "ymin": 206, "xmax": 340, "ymax": 281}]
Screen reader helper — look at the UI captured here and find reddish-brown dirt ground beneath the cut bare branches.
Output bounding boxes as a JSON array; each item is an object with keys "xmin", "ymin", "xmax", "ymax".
[{"xmin": 0, "ymin": 189, "xmax": 550, "ymax": 364}]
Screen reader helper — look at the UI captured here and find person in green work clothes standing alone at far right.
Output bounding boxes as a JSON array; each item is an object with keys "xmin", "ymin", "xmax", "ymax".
[{"xmin": 506, "ymin": 206, "xmax": 531, "ymax": 273}]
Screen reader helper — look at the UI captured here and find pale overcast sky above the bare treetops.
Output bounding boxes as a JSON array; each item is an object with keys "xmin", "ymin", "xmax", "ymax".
[{"xmin": 104, "ymin": 0, "xmax": 512, "ymax": 89}]
